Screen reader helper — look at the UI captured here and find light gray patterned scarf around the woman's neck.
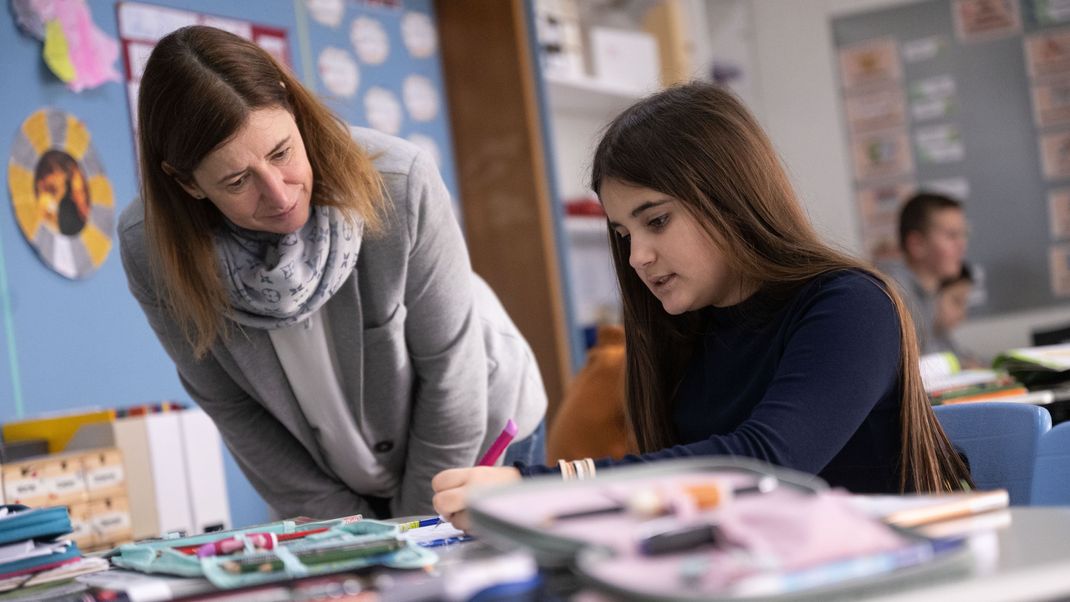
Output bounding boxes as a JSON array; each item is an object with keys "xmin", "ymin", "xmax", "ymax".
[{"xmin": 215, "ymin": 205, "xmax": 364, "ymax": 329}]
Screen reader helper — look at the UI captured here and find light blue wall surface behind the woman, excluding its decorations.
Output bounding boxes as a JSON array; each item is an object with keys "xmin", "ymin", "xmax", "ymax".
[{"xmin": 0, "ymin": 0, "xmax": 456, "ymax": 525}]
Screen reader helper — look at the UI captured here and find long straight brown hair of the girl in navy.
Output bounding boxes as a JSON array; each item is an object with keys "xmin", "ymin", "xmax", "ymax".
[{"xmin": 592, "ymin": 82, "xmax": 970, "ymax": 492}]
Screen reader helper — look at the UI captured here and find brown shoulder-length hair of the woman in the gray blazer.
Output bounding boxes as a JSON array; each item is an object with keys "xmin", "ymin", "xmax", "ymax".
[{"xmin": 138, "ymin": 26, "xmax": 385, "ymax": 357}]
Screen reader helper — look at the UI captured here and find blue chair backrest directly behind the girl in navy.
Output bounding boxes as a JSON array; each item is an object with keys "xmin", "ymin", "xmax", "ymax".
[{"xmin": 933, "ymin": 401, "xmax": 1052, "ymax": 506}]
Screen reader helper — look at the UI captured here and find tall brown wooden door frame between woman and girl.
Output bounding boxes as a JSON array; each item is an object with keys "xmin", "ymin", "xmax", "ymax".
[{"xmin": 435, "ymin": 0, "xmax": 571, "ymax": 421}]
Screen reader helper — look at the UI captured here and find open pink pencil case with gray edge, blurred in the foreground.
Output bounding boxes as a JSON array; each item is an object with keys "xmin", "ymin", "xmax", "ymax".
[{"xmin": 469, "ymin": 458, "xmax": 973, "ymax": 601}]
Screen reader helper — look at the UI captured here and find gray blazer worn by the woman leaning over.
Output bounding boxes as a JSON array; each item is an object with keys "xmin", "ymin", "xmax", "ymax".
[{"xmin": 119, "ymin": 128, "xmax": 546, "ymax": 518}]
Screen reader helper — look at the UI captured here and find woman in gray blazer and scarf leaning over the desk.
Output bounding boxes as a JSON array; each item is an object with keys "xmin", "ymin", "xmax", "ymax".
[{"xmin": 119, "ymin": 26, "xmax": 546, "ymax": 518}]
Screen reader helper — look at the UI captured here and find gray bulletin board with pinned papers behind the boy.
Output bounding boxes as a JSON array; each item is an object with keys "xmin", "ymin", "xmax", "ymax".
[{"xmin": 831, "ymin": 0, "xmax": 1070, "ymax": 315}]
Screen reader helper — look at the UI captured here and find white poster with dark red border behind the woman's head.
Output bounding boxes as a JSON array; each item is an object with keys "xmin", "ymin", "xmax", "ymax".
[{"xmin": 118, "ymin": 2, "xmax": 292, "ymax": 137}]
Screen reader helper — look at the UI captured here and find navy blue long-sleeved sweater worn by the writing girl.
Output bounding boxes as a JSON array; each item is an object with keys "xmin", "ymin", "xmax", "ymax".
[{"xmin": 520, "ymin": 271, "xmax": 901, "ymax": 493}]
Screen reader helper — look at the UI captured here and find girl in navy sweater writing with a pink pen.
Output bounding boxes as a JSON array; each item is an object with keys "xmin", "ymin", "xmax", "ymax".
[{"xmin": 432, "ymin": 83, "xmax": 969, "ymax": 528}]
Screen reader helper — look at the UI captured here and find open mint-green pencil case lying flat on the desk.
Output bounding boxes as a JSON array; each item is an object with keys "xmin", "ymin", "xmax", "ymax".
[{"xmin": 111, "ymin": 519, "xmax": 438, "ymax": 589}]
